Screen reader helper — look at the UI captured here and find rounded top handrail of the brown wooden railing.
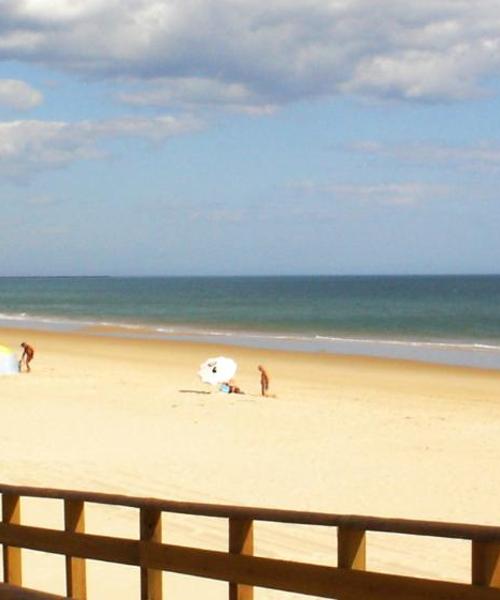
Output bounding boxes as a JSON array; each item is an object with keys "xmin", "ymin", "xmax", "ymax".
[{"xmin": 0, "ymin": 484, "xmax": 500, "ymax": 543}]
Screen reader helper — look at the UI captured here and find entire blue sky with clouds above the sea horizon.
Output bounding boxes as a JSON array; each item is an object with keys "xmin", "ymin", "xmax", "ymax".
[{"xmin": 0, "ymin": 0, "xmax": 500, "ymax": 276}]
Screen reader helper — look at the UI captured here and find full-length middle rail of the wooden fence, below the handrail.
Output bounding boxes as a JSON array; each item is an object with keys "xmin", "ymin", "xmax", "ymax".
[{"xmin": 0, "ymin": 525, "xmax": 500, "ymax": 600}]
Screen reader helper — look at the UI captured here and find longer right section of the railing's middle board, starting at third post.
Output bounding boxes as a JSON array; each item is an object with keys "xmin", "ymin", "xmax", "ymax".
[{"xmin": 144, "ymin": 544, "xmax": 500, "ymax": 600}]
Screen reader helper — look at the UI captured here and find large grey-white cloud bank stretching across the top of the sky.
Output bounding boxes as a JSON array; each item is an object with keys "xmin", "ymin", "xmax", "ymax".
[{"xmin": 0, "ymin": 0, "xmax": 500, "ymax": 112}]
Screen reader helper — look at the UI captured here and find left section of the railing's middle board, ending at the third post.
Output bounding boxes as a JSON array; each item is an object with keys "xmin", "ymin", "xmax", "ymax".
[{"xmin": 0, "ymin": 523, "xmax": 141, "ymax": 567}]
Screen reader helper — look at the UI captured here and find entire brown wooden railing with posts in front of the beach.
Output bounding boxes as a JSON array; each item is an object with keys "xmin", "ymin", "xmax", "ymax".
[{"xmin": 0, "ymin": 485, "xmax": 500, "ymax": 600}]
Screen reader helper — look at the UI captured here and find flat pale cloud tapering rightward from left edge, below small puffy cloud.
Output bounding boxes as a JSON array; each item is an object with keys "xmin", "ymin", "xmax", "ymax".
[{"xmin": 0, "ymin": 116, "xmax": 201, "ymax": 176}]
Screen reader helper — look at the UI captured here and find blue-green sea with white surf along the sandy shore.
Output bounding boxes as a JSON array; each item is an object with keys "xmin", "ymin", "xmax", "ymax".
[{"xmin": 0, "ymin": 275, "xmax": 500, "ymax": 369}]
